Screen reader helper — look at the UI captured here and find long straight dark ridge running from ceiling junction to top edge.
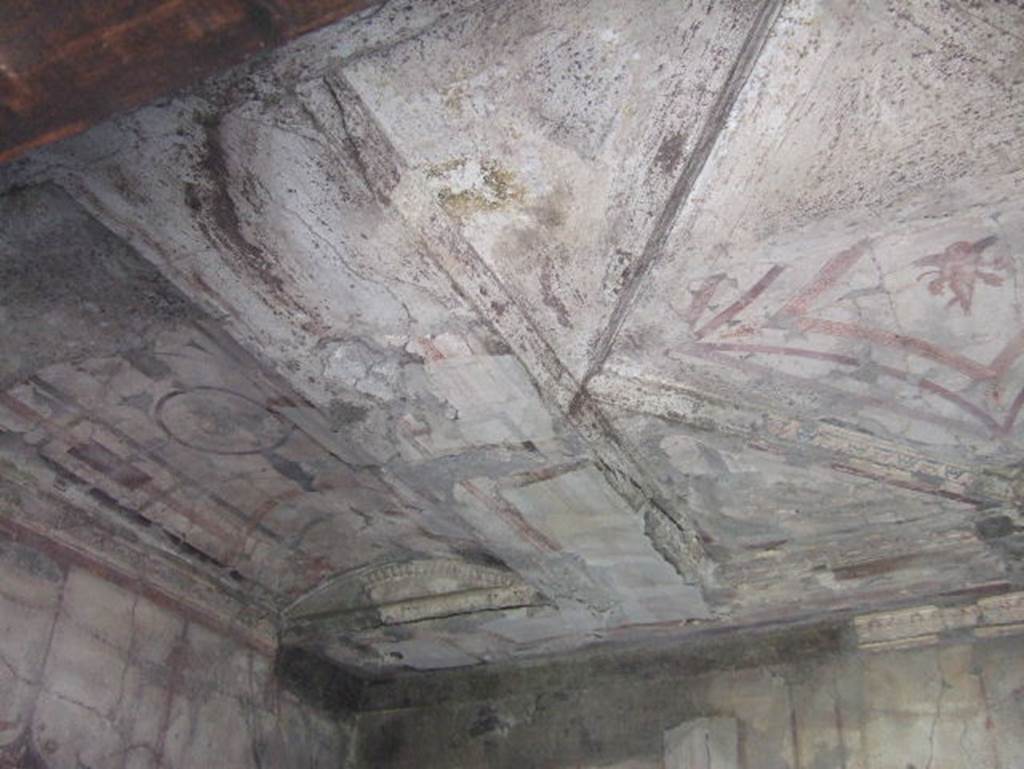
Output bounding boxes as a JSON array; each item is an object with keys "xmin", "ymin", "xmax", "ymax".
[{"xmin": 569, "ymin": 0, "xmax": 785, "ymax": 414}]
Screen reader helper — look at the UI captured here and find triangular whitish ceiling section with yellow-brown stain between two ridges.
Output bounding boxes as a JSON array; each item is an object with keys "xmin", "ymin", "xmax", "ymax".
[{"xmin": 345, "ymin": 2, "xmax": 770, "ymax": 376}]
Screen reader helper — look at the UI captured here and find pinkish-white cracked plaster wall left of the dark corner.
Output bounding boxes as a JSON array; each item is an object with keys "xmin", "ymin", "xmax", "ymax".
[{"xmin": 0, "ymin": 539, "xmax": 348, "ymax": 769}]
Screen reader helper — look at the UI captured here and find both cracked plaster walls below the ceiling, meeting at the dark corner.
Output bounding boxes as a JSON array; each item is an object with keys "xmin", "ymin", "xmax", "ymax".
[{"xmin": 8, "ymin": 524, "xmax": 1024, "ymax": 769}]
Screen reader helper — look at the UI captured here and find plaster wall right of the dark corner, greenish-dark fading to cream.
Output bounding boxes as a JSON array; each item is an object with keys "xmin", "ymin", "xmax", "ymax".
[{"xmin": 358, "ymin": 626, "xmax": 1024, "ymax": 769}]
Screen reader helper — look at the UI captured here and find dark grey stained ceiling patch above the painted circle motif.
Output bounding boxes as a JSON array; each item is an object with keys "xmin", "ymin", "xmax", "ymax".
[{"xmin": 0, "ymin": 185, "xmax": 202, "ymax": 390}]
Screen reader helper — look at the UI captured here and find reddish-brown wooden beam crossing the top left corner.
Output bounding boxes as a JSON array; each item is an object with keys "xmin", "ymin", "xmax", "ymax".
[{"xmin": 0, "ymin": 0, "xmax": 381, "ymax": 163}]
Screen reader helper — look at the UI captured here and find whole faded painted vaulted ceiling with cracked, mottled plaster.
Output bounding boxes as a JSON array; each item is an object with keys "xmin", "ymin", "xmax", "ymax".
[{"xmin": 0, "ymin": 0, "xmax": 1024, "ymax": 673}]
